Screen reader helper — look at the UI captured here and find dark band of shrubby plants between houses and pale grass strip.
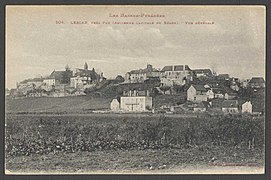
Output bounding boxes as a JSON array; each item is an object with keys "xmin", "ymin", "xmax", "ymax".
[{"xmin": 5, "ymin": 115, "xmax": 264, "ymax": 156}]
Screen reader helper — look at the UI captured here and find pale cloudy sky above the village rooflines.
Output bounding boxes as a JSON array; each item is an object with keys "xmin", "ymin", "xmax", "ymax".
[{"xmin": 6, "ymin": 6, "xmax": 266, "ymax": 88}]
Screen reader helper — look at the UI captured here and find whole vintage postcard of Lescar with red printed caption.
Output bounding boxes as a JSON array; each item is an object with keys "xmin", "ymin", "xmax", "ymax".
[{"xmin": 5, "ymin": 5, "xmax": 266, "ymax": 174}]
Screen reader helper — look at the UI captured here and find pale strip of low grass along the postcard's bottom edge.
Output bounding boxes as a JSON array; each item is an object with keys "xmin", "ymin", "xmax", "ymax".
[{"xmin": 6, "ymin": 147, "xmax": 264, "ymax": 174}]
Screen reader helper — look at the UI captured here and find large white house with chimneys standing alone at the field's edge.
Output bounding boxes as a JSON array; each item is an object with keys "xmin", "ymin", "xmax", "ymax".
[{"xmin": 120, "ymin": 91, "xmax": 152, "ymax": 112}]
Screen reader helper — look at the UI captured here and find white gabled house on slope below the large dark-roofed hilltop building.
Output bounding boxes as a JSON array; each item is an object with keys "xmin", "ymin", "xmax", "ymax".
[{"xmin": 187, "ymin": 85, "xmax": 208, "ymax": 101}]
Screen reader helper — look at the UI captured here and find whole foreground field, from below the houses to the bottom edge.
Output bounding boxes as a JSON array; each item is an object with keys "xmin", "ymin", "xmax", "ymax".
[{"xmin": 5, "ymin": 114, "xmax": 264, "ymax": 173}]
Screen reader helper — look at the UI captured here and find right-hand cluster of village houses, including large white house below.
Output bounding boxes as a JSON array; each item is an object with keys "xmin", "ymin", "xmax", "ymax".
[{"xmin": 110, "ymin": 64, "xmax": 265, "ymax": 114}]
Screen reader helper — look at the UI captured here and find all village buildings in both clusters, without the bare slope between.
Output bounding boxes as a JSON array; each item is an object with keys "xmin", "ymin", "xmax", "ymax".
[{"xmin": 6, "ymin": 63, "xmax": 265, "ymax": 114}]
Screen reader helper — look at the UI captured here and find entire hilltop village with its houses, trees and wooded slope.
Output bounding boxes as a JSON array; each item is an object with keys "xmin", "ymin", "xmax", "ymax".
[{"xmin": 6, "ymin": 63, "xmax": 265, "ymax": 115}]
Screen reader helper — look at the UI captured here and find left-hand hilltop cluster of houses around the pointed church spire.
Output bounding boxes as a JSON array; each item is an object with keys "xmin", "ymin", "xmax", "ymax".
[{"xmin": 9, "ymin": 63, "xmax": 105, "ymax": 97}]
